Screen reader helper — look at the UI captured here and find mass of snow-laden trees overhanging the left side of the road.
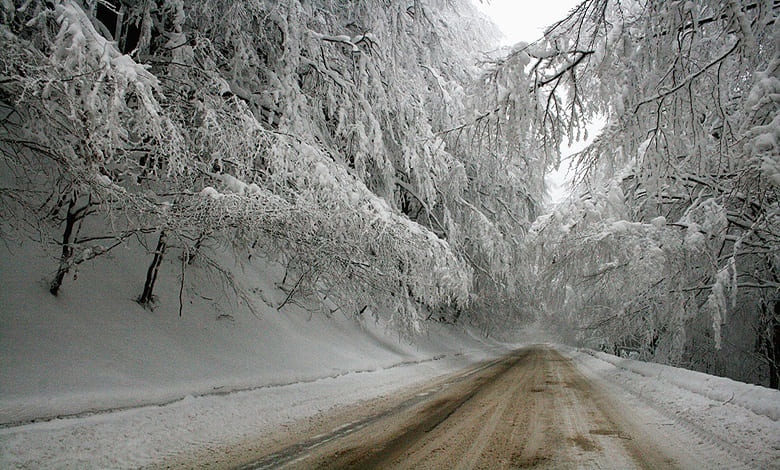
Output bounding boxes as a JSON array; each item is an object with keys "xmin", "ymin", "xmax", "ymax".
[{"xmin": 0, "ymin": 0, "xmax": 539, "ymax": 330}]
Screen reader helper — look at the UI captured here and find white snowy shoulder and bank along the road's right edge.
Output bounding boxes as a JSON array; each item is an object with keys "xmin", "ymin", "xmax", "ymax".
[{"xmin": 558, "ymin": 346, "xmax": 780, "ymax": 468}]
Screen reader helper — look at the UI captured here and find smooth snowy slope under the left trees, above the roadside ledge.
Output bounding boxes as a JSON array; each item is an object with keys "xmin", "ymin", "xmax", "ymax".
[{"xmin": 0, "ymin": 235, "xmax": 508, "ymax": 425}]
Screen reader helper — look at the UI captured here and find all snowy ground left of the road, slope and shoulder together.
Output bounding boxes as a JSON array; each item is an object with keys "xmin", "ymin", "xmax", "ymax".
[{"xmin": 0, "ymin": 235, "xmax": 507, "ymax": 468}]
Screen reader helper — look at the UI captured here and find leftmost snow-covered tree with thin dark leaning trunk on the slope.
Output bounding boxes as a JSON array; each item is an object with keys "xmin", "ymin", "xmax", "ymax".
[{"xmin": 0, "ymin": 2, "xmax": 184, "ymax": 295}]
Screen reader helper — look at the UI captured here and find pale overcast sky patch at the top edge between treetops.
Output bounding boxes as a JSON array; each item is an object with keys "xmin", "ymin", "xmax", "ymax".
[{"xmin": 473, "ymin": 0, "xmax": 582, "ymax": 45}]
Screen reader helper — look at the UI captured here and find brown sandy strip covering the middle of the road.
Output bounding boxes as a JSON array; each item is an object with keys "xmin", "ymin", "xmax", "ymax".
[{"xmin": 295, "ymin": 348, "xmax": 676, "ymax": 469}]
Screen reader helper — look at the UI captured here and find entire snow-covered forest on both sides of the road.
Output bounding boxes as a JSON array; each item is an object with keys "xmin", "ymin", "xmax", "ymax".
[{"xmin": 0, "ymin": 0, "xmax": 780, "ymax": 388}]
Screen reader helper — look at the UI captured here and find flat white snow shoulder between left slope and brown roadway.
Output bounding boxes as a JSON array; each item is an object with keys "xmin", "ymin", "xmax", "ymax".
[{"xmin": 0, "ymin": 356, "xmax": 500, "ymax": 469}]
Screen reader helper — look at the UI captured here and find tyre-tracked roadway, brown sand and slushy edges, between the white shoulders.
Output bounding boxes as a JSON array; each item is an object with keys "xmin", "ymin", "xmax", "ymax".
[{"xmin": 242, "ymin": 346, "xmax": 760, "ymax": 469}]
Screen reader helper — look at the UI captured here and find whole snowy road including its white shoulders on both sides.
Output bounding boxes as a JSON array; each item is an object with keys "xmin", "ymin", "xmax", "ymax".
[{"xmin": 0, "ymin": 345, "xmax": 780, "ymax": 469}]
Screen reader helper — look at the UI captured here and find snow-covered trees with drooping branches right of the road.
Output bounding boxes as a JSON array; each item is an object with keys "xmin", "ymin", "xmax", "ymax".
[{"xmin": 506, "ymin": 0, "xmax": 780, "ymax": 386}]
